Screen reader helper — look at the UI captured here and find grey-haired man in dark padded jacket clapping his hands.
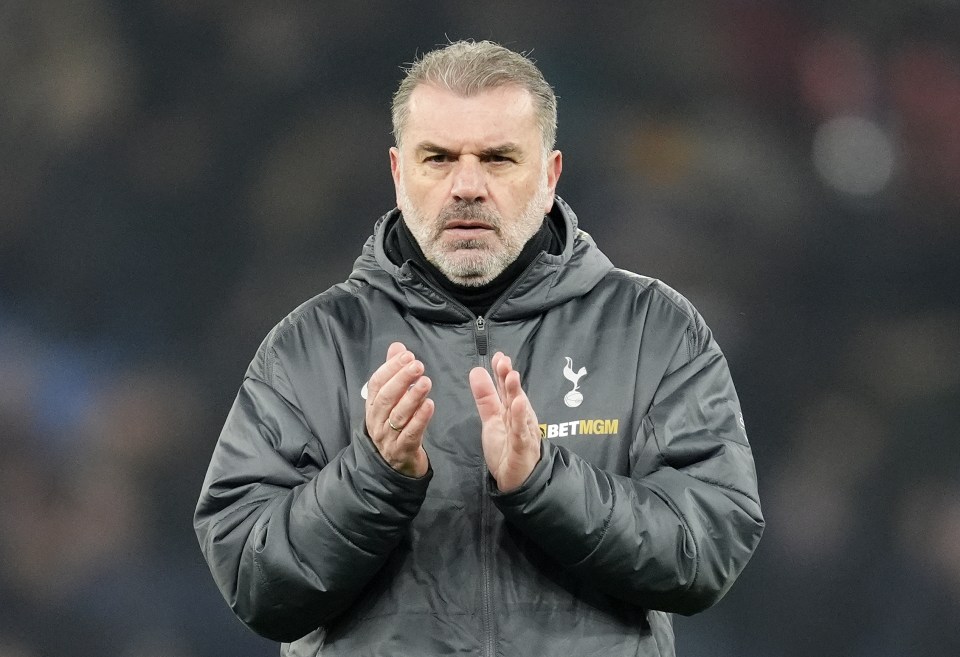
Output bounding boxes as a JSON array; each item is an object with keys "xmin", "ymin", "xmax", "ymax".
[{"xmin": 195, "ymin": 42, "xmax": 763, "ymax": 657}]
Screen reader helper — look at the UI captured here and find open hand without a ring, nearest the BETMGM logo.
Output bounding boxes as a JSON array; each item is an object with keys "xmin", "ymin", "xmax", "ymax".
[{"xmin": 470, "ymin": 351, "xmax": 541, "ymax": 492}]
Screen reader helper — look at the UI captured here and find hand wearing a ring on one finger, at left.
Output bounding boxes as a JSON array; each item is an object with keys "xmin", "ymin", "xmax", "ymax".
[{"xmin": 365, "ymin": 342, "xmax": 434, "ymax": 477}]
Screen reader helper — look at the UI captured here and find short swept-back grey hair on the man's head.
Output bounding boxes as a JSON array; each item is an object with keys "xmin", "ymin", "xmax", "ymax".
[{"xmin": 392, "ymin": 40, "xmax": 557, "ymax": 153}]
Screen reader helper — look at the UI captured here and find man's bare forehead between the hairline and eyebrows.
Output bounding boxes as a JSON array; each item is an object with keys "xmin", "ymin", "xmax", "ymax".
[{"xmin": 404, "ymin": 84, "xmax": 540, "ymax": 146}]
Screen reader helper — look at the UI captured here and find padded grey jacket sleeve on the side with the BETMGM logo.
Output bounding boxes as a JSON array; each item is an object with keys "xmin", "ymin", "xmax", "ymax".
[{"xmin": 494, "ymin": 308, "xmax": 764, "ymax": 614}]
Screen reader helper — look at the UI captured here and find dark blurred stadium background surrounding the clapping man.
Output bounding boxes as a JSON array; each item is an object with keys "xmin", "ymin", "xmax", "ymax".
[{"xmin": 0, "ymin": 0, "xmax": 960, "ymax": 657}]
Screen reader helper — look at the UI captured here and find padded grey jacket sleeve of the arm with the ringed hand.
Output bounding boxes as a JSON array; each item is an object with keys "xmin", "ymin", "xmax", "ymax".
[{"xmin": 194, "ymin": 348, "xmax": 432, "ymax": 641}]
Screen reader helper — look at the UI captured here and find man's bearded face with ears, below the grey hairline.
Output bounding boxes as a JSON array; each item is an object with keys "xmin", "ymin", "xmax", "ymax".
[{"xmin": 390, "ymin": 84, "xmax": 562, "ymax": 286}]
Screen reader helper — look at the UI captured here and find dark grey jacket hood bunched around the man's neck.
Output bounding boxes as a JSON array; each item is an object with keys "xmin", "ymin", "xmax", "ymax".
[{"xmin": 349, "ymin": 196, "xmax": 613, "ymax": 323}]
